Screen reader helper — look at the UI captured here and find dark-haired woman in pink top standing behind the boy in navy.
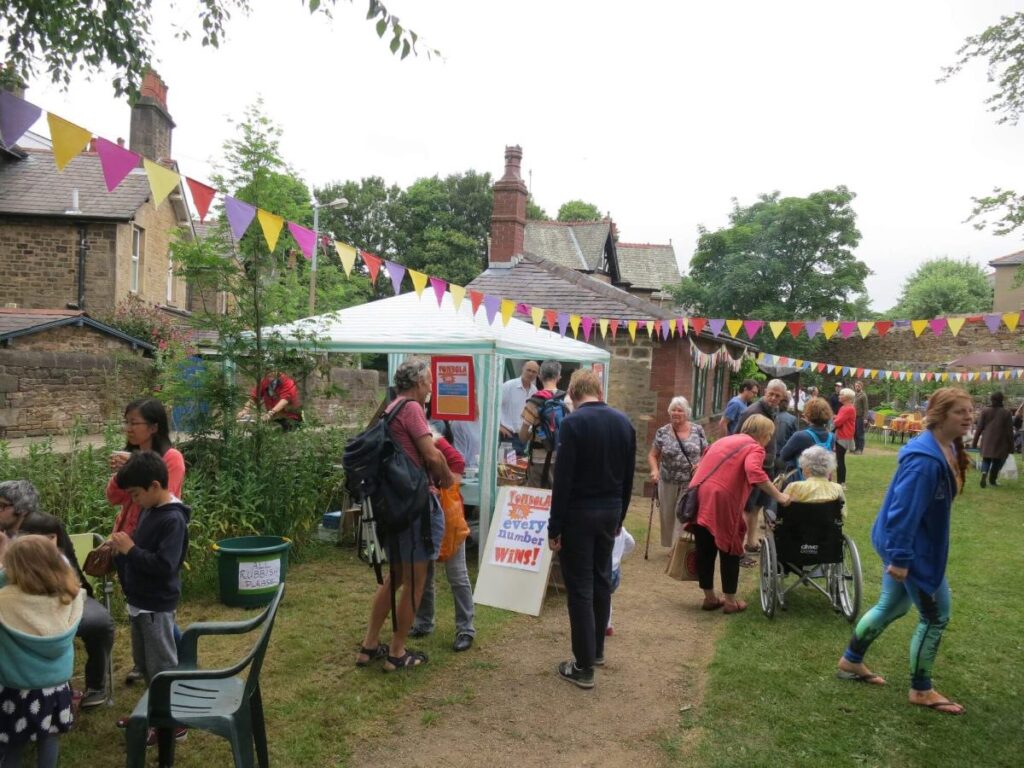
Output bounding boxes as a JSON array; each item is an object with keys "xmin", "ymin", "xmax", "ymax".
[{"xmin": 106, "ymin": 397, "xmax": 185, "ymax": 536}]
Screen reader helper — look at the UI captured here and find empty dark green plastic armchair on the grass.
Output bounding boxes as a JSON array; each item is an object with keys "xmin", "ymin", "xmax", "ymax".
[{"xmin": 125, "ymin": 584, "xmax": 285, "ymax": 768}]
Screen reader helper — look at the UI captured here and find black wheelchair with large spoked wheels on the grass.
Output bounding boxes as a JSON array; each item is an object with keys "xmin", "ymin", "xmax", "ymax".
[{"xmin": 761, "ymin": 500, "xmax": 863, "ymax": 623}]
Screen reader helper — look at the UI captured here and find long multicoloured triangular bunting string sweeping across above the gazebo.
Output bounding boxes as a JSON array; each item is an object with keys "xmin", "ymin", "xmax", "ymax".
[{"xmin": 0, "ymin": 91, "xmax": 1024, "ymax": 339}]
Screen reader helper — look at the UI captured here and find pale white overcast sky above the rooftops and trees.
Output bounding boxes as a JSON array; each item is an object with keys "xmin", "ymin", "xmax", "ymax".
[{"xmin": 19, "ymin": 0, "xmax": 1024, "ymax": 310}]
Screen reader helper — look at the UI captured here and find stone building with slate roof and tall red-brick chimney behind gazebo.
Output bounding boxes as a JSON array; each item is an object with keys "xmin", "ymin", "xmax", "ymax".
[{"xmin": 468, "ymin": 146, "xmax": 751, "ymax": 488}]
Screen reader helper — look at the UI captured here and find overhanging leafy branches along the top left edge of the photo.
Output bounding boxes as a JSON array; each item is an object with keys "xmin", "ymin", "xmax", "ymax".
[{"xmin": 0, "ymin": 0, "xmax": 440, "ymax": 98}]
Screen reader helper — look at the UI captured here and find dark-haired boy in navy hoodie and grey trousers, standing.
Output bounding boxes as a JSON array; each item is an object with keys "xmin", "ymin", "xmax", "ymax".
[{"xmin": 111, "ymin": 451, "xmax": 191, "ymax": 700}]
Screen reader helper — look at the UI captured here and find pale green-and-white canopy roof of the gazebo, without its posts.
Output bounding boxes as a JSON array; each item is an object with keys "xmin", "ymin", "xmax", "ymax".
[{"xmin": 264, "ymin": 290, "xmax": 610, "ymax": 362}]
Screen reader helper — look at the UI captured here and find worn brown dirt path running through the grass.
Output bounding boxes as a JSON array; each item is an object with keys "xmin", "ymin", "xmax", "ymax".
[{"xmin": 351, "ymin": 502, "xmax": 729, "ymax": 768}]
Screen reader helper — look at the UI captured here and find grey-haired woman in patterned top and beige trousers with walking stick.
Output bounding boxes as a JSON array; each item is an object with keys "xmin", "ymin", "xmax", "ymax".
[{"xmin": 647, "ymin": 395, "xmax": 708, "ymax": 547}]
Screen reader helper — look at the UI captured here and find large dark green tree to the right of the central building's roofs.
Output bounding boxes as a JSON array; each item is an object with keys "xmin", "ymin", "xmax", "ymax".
[{"xmin": 673, "ymin": 186, "xmax": 870, "ymax": 352}]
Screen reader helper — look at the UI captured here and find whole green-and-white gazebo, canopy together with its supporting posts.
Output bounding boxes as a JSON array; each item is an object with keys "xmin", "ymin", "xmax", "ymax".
[{"xmin": 264, "ymin": 291, "xmax": 610, "ymax": 553}]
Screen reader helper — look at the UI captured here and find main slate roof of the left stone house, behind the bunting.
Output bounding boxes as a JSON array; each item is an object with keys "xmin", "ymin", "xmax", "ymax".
[{"xmin": 0, "ymin": 150, "xmax": 150, "ymax": 221}]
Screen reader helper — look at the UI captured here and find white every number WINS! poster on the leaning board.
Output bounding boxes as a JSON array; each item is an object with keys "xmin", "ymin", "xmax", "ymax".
[{"xmin": 489, "ymin": 486, "xmax": 551, "ymax": 572}]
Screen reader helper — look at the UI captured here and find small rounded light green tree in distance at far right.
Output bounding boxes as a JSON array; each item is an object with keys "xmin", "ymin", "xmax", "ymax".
[{"xmin": 890, "ymin": 258, "xmax": 992, "ymax": 319}]
